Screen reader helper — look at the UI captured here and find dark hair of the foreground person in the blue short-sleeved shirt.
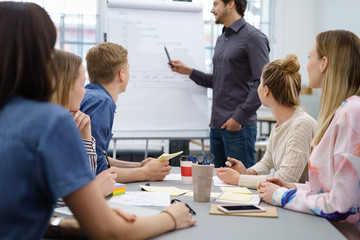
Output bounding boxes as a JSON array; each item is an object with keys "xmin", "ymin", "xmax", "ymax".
[{"xmin": 0, "ymin": 2, "xmax": 56, "ymax": 106}]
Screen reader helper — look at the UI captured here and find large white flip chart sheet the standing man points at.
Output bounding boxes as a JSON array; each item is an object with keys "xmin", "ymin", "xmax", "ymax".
[{"xmin": 105, "ymin": 0, "xmax": 209, "ymax": 137}]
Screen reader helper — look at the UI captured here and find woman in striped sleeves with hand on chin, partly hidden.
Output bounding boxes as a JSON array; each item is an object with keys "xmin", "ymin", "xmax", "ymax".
[{"xmin": 52, "ymin": 49, "xmax": 117, "ymax": 196}]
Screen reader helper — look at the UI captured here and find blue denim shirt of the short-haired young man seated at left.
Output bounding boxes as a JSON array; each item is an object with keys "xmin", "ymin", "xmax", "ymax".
[{"xmin": 80, "ymin": 83, "xmax": 116, "ymax": 174}]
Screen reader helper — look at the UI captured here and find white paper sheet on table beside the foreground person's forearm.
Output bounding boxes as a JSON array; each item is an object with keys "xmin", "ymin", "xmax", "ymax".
[{"xmin": 109, "ymin": 191, "xmax": 170, "ymax": 207}]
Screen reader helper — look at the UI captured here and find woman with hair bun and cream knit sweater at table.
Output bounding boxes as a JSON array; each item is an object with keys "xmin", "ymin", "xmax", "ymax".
[{"xmin": 216, "ymin": 54, "xmax": 317, "ymax": 188}]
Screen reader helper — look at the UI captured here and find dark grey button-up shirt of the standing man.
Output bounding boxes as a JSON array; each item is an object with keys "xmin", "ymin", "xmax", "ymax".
[{"xmin": 190, "ymin": 18, "xmax": 270, "ymax": 129}]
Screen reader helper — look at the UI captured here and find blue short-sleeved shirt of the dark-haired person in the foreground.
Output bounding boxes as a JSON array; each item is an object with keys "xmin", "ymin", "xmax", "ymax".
[{"xmin": 0, "ymin": 96, "xmax": 95, "ymax": 239}]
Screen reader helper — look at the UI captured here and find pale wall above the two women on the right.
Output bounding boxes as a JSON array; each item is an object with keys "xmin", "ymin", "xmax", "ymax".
[{"xmin": 270, "ymin": 0, "xmax": 360, "ymax": 86}]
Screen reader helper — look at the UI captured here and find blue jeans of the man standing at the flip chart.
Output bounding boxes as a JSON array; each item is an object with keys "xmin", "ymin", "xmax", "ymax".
[{"xmin": 210, "ymin": 125, "xmax": 257, "ymax": 168}]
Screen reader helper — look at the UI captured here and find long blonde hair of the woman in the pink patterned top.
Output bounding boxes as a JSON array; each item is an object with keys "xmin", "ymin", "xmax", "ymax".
[{"xmin": 312, "ymin": 30, "xmax": 360, "ymax": 146}]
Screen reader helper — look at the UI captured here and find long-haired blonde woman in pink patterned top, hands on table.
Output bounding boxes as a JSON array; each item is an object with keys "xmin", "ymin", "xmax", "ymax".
[{"xmin": 258, "ymin": 30, "xmax": 360, "ymax": 223}]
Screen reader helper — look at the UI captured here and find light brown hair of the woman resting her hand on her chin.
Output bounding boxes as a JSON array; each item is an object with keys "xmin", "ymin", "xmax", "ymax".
[{"xmin": 51, "ymin": 49, "xmax": 81, "ymax": 109}]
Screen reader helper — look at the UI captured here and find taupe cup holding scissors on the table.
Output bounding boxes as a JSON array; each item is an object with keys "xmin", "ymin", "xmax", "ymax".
[{"xmin": 192, "ymin": 164, "xmax": 214, "ymax": 202}]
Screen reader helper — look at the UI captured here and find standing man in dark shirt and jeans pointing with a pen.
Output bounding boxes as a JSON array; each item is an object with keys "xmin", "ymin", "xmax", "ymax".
[{"xmin": 172, "ymin": 0, "xmax": 270, "ymax": 168}]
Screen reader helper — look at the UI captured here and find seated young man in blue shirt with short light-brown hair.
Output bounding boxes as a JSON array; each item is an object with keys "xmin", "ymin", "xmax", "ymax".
[{"xmin": 80, "ymin": 42, "xmax": 171, "ymax": 182}]
